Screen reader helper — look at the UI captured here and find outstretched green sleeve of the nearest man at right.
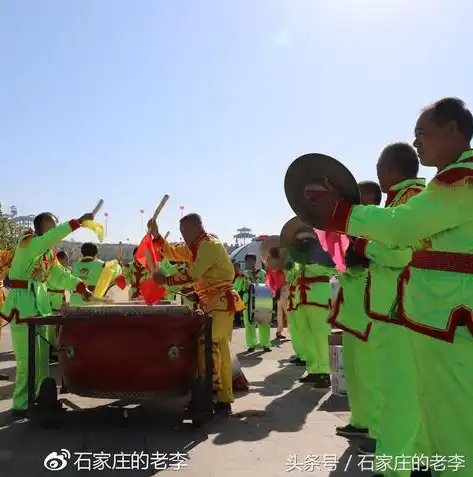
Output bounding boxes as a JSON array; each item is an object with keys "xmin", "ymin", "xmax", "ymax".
[{"xmin": 344, "ymin": 185, "xmax": 466, "ymax": 247}]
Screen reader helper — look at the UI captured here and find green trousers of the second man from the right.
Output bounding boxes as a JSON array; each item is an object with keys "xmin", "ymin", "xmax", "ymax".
[{"xmin": 369, "ymin": 321, "xmax": 428, "ymax": 477}]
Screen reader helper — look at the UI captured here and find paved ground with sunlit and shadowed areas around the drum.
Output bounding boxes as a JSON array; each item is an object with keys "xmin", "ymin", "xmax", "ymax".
[{"xmin": 0, "ymin": 320, "xmax": 371, "ymax": 477}]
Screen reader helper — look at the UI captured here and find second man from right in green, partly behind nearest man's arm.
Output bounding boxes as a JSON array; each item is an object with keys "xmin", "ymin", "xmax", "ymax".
[{"xmin": 348, "ymin": 142, "xmax": 425, "ymax": 462}]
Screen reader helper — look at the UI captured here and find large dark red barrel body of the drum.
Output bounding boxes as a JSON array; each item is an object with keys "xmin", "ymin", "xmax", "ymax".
[{"xmin": 59, "ymin": 304, "xmax": 206, "ymax": 399}]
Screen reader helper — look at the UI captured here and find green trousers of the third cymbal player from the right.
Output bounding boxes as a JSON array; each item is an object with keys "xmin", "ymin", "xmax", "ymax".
[{"xmin": 343, "ymin": 333, "xmax": 381, "ymax": 439}]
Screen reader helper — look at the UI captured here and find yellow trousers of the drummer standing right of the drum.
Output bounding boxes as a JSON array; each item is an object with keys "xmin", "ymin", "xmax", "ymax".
[{"xmin": 199, "ymin": 310, "xmax": 235, "ymax": 403}]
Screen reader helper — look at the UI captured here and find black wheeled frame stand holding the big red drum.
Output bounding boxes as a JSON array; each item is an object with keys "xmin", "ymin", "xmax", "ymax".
[{"xmin": 21, "ymin": 315, "xmax": 214, "ymax": 427}]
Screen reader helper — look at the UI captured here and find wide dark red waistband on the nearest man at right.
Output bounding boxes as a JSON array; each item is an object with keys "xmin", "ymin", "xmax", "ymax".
[{"xmin": 409, "ymin": 250, "xmax": 473, "ymax": 274}]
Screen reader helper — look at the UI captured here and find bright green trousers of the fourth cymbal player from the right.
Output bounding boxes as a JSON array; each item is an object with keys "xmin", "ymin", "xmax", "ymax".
[{"xmin": 297, "ymin": 305, "xmax": 332, "ymax": 374}]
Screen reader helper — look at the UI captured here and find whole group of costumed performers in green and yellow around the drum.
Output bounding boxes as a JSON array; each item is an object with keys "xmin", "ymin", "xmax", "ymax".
[{"xmin": 0, "ymin": 98, "xmax": 473, "ymax": 477}]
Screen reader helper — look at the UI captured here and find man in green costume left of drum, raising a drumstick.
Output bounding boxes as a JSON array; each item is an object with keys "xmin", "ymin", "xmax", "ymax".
[{"xmin": 2, "ymin": 212, "xmax": 94, "ymax": 417}]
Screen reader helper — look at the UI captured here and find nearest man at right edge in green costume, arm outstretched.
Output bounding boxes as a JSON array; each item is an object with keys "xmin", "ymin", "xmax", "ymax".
[{"xmin": 312, "ymin": 98, "xmax": 473, "ymax": 477}]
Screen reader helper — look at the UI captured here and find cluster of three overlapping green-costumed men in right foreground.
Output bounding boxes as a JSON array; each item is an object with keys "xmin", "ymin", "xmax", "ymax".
[{"xmin": 302, "ymin": 98, "xmax": 473, "ymax": 477}]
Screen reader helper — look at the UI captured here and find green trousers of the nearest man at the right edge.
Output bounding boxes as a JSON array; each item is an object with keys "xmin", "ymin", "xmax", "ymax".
[{"xmin": 409, "ymin": 327, "xmax": 473, "ymax": 477}]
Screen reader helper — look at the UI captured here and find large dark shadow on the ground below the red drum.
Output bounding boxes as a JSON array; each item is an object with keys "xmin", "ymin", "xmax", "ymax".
[{"xmin": 0, "ymin": 406, "xmax": 207, "ymax": 477}]
